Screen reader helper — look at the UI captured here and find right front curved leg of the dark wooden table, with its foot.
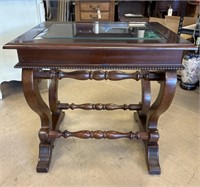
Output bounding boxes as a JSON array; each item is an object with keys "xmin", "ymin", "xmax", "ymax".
[{"xmin": 146, "ymin": 71, "xmax": 177, "ymax": 174}]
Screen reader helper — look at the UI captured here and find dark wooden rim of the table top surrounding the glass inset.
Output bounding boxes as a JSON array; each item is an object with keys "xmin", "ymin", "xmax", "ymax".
[{"xmin": 3, "ymin": 22, "xmax": 197, "ymax": 50}]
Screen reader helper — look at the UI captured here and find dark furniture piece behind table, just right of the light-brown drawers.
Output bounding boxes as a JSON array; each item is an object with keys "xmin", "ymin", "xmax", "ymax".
[{"xmin": 118, "ymin": 1, "xmax": 151, "ymax": 22}]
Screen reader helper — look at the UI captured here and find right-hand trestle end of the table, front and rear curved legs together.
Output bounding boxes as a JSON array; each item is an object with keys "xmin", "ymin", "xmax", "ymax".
[{"xmin": 135, "ymin": 71, "xmax": 177, "ymax": 174}]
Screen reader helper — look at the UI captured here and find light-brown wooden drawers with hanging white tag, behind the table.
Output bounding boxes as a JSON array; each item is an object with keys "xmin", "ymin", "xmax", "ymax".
[{"xmin": 75, "ymin": 0, "xmax": 115, "ymax": 21}]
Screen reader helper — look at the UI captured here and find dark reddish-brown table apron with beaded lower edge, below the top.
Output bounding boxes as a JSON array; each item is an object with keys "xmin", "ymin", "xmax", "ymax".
[{"xmin": 17, "ymin": 49, "xmax": 183, "ymax": 69}]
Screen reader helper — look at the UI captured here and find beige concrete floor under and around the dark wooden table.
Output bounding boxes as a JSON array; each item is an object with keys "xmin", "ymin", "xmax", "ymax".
[{"xmin": 0, "ymin": 76, "xmax": 200, "ymax": 187}]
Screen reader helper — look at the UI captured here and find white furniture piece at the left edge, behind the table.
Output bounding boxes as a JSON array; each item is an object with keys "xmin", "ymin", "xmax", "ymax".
[{"xmin": 0, "ymin": 0, "xmax": 45, "ymax": 99}]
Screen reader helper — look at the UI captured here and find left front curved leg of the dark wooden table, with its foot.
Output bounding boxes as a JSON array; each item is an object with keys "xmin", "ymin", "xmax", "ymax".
[{"xmin": 22, "ymin": 69, "xmax": 52, "ymax": 172}]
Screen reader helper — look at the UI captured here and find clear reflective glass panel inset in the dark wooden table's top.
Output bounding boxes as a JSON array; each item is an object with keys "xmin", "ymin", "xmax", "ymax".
[{"xmin": 35, "ymin": 22, "xmax": 164, "ymax": 40}]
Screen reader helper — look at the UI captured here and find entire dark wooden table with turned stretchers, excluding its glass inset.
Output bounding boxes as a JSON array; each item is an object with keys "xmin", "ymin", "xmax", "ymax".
[{"xmin": 4, "ymin": 22, "xmax": 196, "ymax": 174}]
